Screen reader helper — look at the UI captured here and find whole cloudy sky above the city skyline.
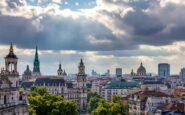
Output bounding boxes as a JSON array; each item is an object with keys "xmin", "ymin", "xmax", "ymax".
[{"xmin": 0, "ymin": 0, "xmax": 185, "ymax": 75}]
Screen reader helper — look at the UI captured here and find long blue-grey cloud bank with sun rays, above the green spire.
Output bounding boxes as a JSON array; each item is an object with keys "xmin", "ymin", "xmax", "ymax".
[{"xmin": 0, "ymin": 15, "xmax": 136, "ymax": 50}]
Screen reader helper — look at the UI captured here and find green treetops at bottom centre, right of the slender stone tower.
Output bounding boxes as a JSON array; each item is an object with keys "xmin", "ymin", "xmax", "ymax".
[{"xmin": 88, "ymin": 93, "xmax": 128, "ymax": 115}]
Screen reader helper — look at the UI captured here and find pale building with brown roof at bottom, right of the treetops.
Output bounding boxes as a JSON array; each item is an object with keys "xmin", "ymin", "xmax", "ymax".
[{"xmin": 129, "ymin": 91, "xmax": 168, "ymax": 115}]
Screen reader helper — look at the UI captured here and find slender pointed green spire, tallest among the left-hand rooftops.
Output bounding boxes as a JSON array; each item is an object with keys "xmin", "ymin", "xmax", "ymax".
[{"xmin": 33, "ymin": 46, "xmax": 40, "ymax": 74}]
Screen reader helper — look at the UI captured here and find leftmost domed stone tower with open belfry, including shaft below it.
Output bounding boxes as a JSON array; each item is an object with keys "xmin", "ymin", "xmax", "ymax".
[{"xmin": 4, "ymin": 43, "xmax": 19, "ymax": 87}]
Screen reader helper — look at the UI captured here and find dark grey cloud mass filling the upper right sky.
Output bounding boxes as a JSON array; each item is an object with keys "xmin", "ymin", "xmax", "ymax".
[{"xmin": 116, "ymin": 1, "xmax": 185, "ymax": 46}]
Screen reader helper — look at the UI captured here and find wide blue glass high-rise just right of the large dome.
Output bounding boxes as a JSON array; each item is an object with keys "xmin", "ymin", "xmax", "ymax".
[{"xmin": 158, "ymin": 63, "xmax": 170, "ymax": 77}]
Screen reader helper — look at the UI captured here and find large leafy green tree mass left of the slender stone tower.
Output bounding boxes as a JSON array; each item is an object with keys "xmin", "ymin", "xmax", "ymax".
[{"xmin": 28, "ymin": 87, "xmax": 78, "ymax": 115}]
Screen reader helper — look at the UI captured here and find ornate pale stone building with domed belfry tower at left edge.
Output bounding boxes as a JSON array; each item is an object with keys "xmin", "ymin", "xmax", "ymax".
[{"xmin": 0, "ymin": 44, "xmax": 28, "ymax": 115}]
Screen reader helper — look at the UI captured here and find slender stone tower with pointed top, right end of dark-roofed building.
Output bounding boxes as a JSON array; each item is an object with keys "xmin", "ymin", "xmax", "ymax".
[{"xmin": 77, "ymin": 59, "xmax": 87, "ymax": 110}]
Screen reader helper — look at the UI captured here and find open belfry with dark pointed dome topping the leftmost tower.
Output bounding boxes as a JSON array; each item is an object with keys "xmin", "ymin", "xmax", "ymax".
[{"xmin": 5, "ymin": 43, "xmax": 18, "ymax": 74}]
